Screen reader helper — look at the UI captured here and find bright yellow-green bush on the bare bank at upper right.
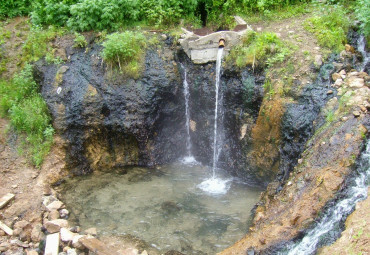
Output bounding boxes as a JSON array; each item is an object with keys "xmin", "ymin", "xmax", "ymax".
[{"xmin": 305, "ymin": 5, "xmax": 349, "ymax": 52}]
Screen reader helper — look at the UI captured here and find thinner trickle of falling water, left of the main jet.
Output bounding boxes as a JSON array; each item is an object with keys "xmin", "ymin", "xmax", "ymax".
[{"xmin": 181, "ymin": 64, "xmax": 196, "ymax": 164}]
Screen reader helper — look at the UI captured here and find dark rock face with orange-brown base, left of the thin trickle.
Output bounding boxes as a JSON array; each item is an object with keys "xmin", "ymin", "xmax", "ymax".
[{"xmin": 36, "ymin": 40, "xmax": 184, "ymax": 173}]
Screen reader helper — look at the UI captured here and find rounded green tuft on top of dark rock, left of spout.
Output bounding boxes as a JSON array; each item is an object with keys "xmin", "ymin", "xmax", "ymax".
[{"xmin": 102, "ymin": 31, "xmax": 146, "ymax": 78}]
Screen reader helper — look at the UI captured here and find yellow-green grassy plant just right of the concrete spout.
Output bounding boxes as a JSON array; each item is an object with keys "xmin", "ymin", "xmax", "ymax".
[{"xmin": 227, "ymin": 31, "xmax": 292, "ymax": 68}]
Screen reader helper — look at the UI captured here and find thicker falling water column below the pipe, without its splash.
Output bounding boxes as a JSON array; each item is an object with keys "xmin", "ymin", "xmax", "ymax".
[{"xmin": 212, "ymin": 47, "xmax": 224, "ymax": 178}]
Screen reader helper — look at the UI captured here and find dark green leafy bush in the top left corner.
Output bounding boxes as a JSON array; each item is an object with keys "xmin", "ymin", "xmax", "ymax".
[{"xmin": 0, "ymin": 0, "xmax": 32, "ymax": 19}]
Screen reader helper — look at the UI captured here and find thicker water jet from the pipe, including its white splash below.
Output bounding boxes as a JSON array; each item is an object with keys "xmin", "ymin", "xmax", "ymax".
[{"xmin": 198, "ymin": 47, "xmax": 231, "ymax": 195}]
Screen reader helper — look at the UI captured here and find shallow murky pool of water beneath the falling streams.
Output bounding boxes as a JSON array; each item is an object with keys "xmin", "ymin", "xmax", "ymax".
[{"xmin": 61, "ymin": 163, "xmax": 261, "ymax": 254}]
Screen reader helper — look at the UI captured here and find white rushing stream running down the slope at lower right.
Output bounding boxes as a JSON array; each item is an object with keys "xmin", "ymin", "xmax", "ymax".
[{"xmin": 279, "ymin": 140, "xmax": 370, "ymax": 255}]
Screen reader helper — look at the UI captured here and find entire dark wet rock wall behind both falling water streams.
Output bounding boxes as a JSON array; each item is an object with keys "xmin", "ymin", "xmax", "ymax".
[{"xmin": 35, "ymin": 38, "xmax": 263, "ymax": 176}]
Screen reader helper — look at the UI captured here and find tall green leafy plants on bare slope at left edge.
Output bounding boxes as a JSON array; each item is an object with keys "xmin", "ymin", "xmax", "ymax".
[{"xmin": 0, "ymin": 65, "xmax": 54, "ymax": 167}]
